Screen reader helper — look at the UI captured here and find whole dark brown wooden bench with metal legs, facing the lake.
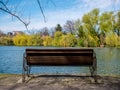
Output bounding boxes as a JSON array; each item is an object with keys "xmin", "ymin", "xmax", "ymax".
[{"xmin": 22, "ymin": 48, "xmax": 97, "ymax": 82}]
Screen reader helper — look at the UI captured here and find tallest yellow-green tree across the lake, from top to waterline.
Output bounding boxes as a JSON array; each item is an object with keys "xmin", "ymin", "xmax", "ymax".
[{"xmin": 81, "ymin": 9, "xmax": 99, "ymax": 46}]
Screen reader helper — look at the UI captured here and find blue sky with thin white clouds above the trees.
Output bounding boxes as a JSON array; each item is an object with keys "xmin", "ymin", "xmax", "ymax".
[{"xmin": 0, "ymin": 0, "xmax": 120, "ymax": 32}]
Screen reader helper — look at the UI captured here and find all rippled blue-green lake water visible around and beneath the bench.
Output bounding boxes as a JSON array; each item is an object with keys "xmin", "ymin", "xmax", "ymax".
[{"xmin": 0, "ymin": 46, "xmax": 120, "ymax": 75}]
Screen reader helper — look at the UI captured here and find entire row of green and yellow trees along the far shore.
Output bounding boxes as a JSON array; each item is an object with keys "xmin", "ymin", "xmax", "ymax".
[{"xmin": 0, "ymin": 9, "xmax": 120, "ymax": 47}]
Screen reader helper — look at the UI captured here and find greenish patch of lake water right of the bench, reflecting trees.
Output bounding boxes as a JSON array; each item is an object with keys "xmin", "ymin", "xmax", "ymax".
[{"xmin": 95, "ymin": 48, "xmax": 120, "ymax": 75}]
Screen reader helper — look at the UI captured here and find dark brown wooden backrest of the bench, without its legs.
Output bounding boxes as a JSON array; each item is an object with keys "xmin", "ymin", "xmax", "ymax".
[{"xmin": 26, "ymin": 48, "xmax": 93, "ymax": 66}]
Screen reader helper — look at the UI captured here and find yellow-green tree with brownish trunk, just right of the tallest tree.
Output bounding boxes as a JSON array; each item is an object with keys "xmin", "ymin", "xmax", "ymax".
[{"xmin": 99, "ymin": 12, "xmax": 115, "ymax": 44}]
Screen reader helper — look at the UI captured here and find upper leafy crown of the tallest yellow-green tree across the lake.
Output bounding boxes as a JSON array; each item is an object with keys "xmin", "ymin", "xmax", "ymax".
[{"xmin": 82, "ymin": 8, "xmax": 99, "ymax": 36}]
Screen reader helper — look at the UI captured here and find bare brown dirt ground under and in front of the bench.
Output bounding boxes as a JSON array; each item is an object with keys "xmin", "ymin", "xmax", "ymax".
[{"xmin": 0, "ymin": 74, "xmax": 120, "ymax": 90}]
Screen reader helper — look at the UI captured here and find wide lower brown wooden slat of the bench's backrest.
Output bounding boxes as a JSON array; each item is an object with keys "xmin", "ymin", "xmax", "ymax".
[{"xmin": 28, "ymin": 56, "xmax": 93, "ymax": 66}]
